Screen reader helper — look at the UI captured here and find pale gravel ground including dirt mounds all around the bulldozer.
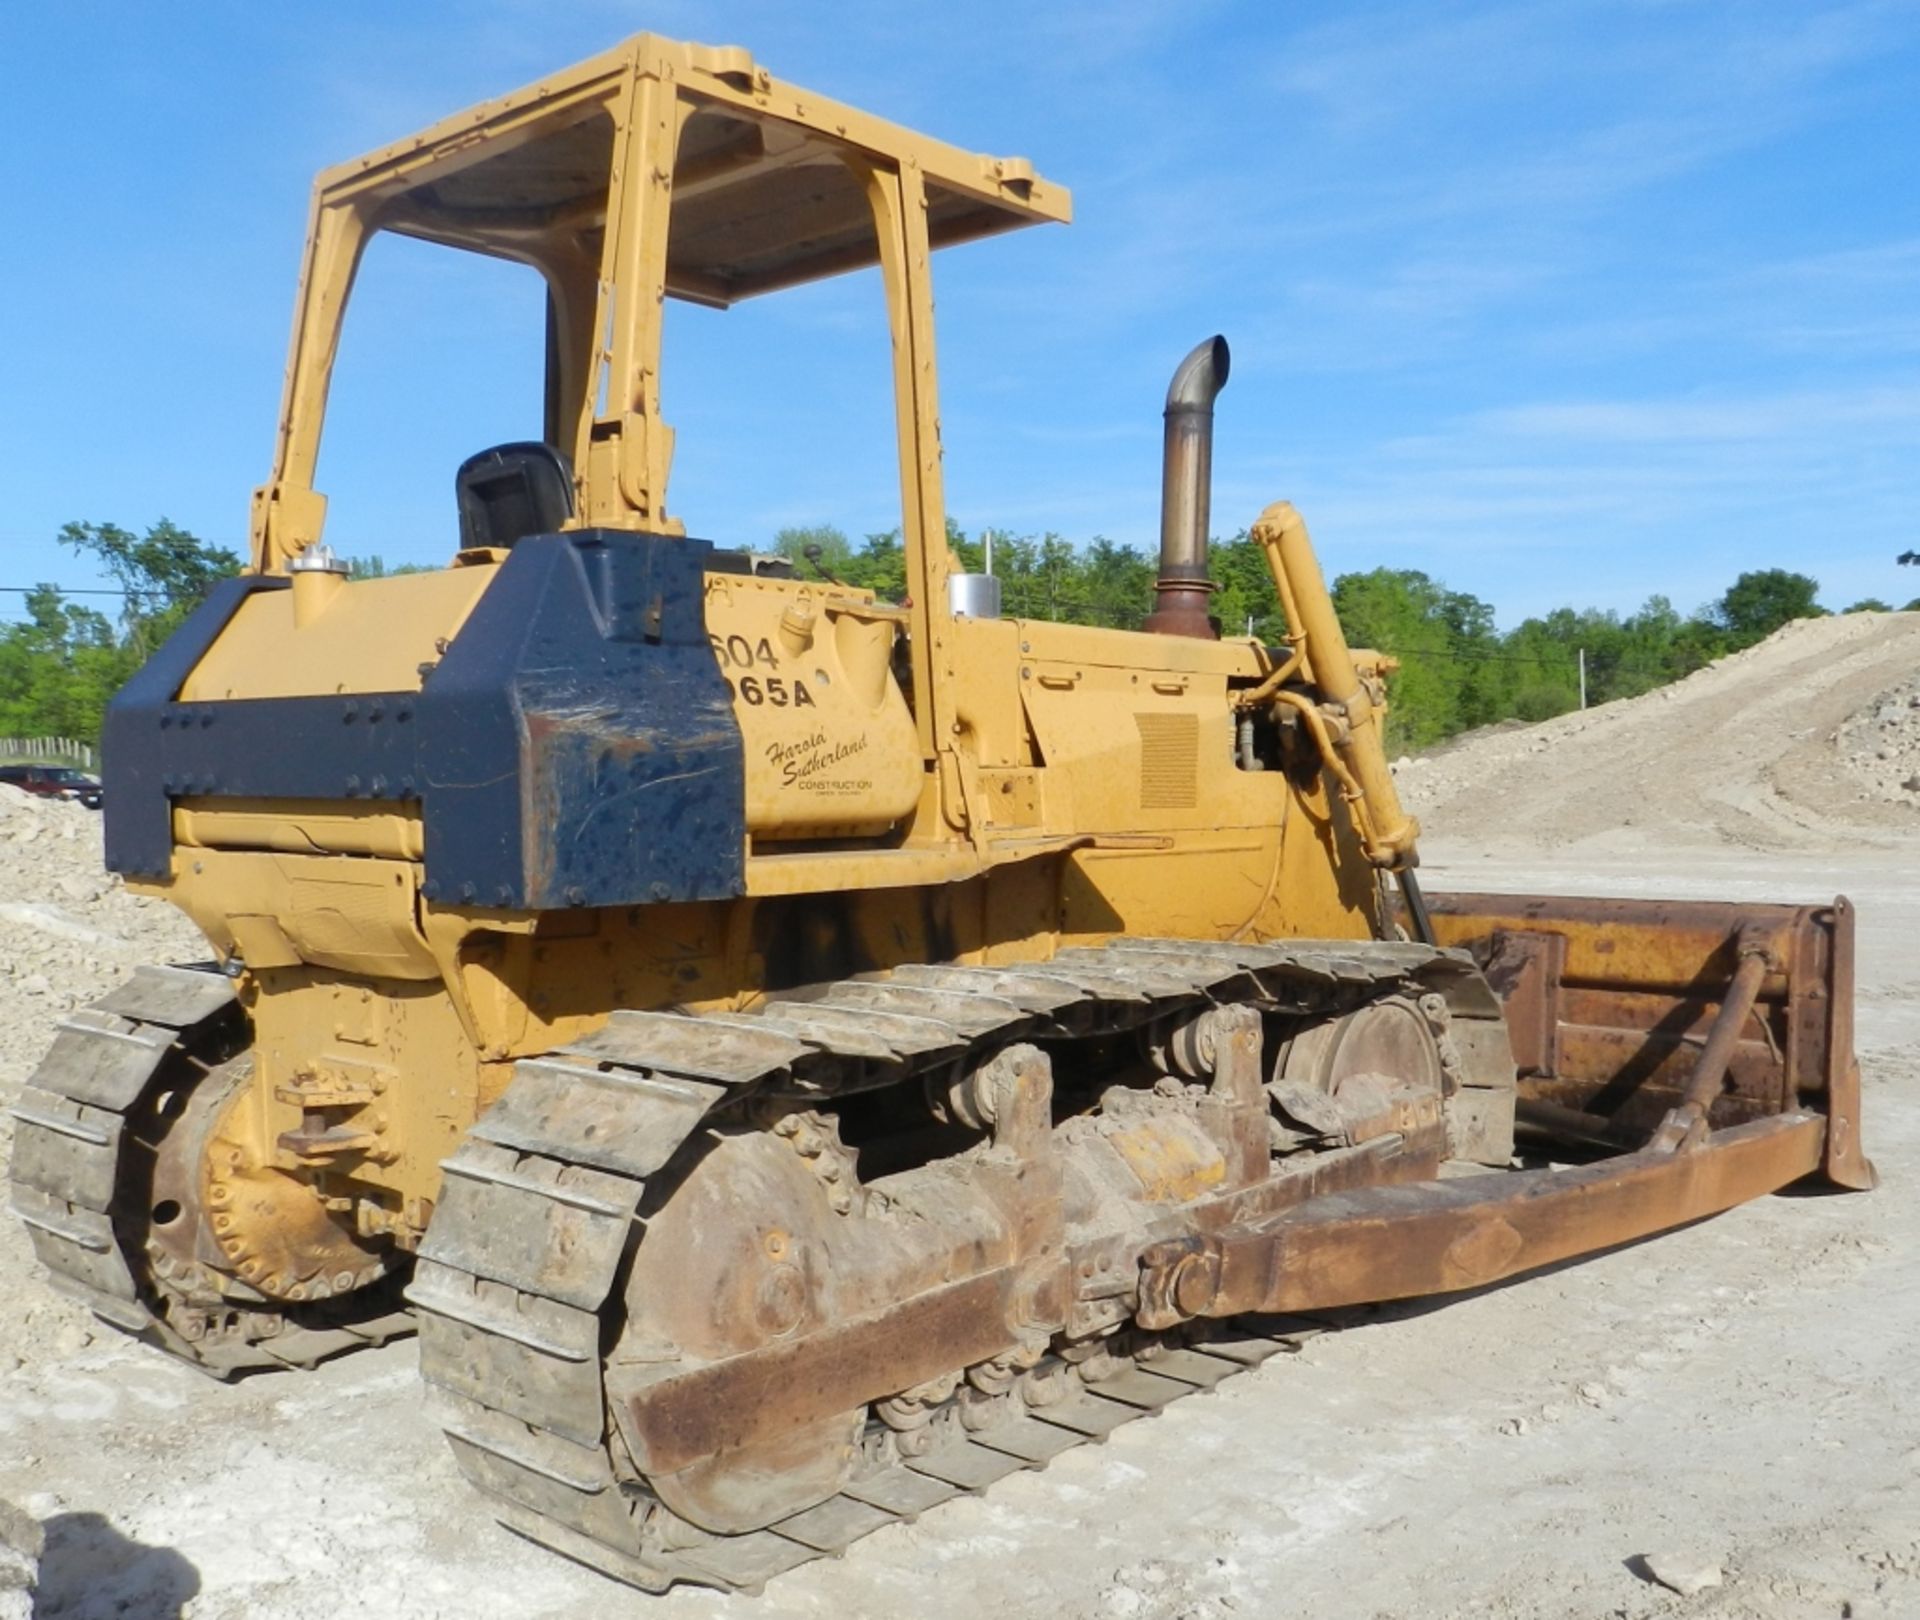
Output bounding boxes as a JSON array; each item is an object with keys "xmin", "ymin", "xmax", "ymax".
[{"xmin": 0, "ymin": 614, "xmax": 1920, "ymax": 1620}]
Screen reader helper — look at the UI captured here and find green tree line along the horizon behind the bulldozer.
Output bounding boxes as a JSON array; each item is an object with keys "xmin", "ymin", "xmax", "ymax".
[{"xmin": 0, "ymin": 518, "xmax": 1920, "ymax": 749}]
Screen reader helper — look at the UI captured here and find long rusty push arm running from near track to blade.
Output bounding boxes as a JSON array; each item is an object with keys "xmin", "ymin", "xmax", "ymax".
[{"xmin": 1142, "ymin": 1115, "xmax": 1826, "ymax": 1326}]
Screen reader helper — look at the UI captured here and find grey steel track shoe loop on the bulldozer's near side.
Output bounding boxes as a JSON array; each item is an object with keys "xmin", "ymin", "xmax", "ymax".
[{"xmin": 409, "ymin": 941, "xmax": 1500, "ymax": 1591}]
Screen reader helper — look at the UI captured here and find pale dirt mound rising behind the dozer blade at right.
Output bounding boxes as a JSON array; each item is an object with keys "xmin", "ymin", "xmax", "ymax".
[{"xmin": 1398, "ymin": 612, "xmax": 1920, "ymax": 858}]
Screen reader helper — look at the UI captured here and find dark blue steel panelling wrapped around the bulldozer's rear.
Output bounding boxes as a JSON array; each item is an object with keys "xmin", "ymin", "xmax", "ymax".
[{"xmin": 102, "ymin": 530, "xmax": 747, "ymax": 910}]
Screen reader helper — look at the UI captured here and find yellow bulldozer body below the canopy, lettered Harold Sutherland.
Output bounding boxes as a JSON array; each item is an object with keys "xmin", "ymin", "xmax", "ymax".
[{"xmin": 156, "ymin": 562, "xmax": 1380, "ymax": 1236}]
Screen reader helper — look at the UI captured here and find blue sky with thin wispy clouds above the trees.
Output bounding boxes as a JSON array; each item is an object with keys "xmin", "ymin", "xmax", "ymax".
[{"xmin": 0, "ymin": 0, "xmax": 1920, "ymax": 626}]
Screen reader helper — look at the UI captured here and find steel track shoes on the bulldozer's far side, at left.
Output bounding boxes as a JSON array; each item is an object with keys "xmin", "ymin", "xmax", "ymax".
[{"xmin": 8, "ymin": 967, "xmax": 413, "ymax": 1378}]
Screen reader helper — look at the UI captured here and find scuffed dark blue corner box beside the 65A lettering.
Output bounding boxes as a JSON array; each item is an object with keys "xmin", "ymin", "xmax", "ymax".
[{"xmin": 419, "ymin": 530, "xmax": 747, "ymax": 910}]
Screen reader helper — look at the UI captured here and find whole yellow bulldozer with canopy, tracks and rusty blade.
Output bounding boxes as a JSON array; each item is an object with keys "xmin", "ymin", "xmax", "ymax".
[{"xmin": 12, "ymin": 35, "xmax": 1872, "ymax": 1591}]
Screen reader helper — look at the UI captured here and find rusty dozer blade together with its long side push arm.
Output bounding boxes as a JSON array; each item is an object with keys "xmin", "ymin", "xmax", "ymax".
[{"xmin": 1139, "ymin": 894, "xmax": 1874, "ymax": 1328}]
